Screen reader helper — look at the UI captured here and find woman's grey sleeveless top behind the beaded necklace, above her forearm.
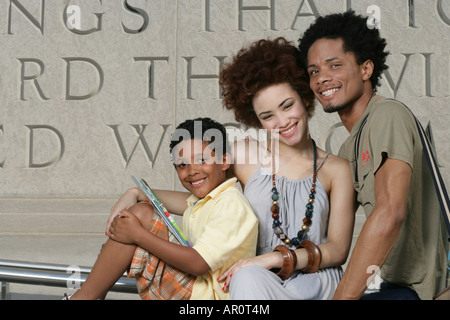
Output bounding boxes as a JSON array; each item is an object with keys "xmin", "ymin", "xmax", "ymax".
[{"xmin": 244, "ymin": 154, "xmax": 330, "ymax": 255}]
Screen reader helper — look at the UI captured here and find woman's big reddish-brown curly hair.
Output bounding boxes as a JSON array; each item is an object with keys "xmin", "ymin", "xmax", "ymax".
[{"xmin": 219, "ymin": 37, "xmax": 315, "ymax": 128}]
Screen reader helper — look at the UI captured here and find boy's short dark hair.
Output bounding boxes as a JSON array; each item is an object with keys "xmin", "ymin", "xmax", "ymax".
[{"xmin": 169, "ymin": 118, "xmax": 229, "ymax": 156}]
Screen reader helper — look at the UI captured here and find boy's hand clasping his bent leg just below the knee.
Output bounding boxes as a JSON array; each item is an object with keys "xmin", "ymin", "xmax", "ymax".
[{"xmin": 108, "ymin": 211, "xmax": 145, "ymax": 244}]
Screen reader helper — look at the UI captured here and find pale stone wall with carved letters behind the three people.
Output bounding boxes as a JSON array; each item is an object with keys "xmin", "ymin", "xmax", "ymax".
[{"xmin": 0, "ymin": 0, "xmax": 450, "ymax": 198}]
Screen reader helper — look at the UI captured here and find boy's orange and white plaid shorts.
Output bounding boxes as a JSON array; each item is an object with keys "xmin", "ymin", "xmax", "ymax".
[{"xmin": 128, "ymin": 212, "xmax": 197, "ymax": 300}]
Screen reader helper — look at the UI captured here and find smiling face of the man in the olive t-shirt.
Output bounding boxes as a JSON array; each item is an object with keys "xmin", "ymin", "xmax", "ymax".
[{"xmin": 307, "ymin": 38, "xmax": 370, "ymax": 112}]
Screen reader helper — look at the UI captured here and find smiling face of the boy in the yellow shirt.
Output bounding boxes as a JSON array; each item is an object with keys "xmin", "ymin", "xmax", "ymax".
[{"xmin": 172, "ymin": 139, "xmax": 230, "ymax": 198}]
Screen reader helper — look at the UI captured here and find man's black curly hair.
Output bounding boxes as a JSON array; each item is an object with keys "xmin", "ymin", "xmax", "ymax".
[{"xmin": 299, "ymin": 10, "xmax": 389, "ymax": 90}]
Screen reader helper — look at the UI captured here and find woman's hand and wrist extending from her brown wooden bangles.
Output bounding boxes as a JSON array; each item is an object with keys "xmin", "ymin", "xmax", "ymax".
[{"xmin": 217, "ymin": 252, "xmax": 283, "ymax": 291}]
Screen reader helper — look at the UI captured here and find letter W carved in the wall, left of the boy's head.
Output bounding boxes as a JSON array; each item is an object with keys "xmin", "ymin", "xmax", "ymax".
[{"xmin": 108, "ymin": 124, "xmax": 170, "ymax": 168}]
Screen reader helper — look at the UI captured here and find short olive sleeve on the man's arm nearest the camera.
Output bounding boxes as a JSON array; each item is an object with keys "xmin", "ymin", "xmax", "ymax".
[{"xmin": 368, "ymin": 100, "xmax": 416, "ymax": 173}]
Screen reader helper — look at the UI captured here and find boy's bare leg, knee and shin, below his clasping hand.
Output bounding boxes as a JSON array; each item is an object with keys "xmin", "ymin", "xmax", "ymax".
[{"xmin": 70, "ymin": 204, "xmax": 153, "ymax": 300}]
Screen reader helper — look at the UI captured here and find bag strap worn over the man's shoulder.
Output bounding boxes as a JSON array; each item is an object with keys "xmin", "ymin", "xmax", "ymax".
[{"xmin": 355, "ymin": 98, "xmax": 450, "ymax": 241}]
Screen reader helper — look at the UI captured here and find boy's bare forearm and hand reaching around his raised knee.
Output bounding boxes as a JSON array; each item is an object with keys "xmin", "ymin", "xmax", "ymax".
[{"xmin": 109, "ymin": 211, "xmax": 210, "ymax": 276}]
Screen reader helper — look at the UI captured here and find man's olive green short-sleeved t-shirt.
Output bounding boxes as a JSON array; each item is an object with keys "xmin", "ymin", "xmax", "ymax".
[{"xmin": 339, "ymin": 95, "xmax": 448, "ymax": 299}]
